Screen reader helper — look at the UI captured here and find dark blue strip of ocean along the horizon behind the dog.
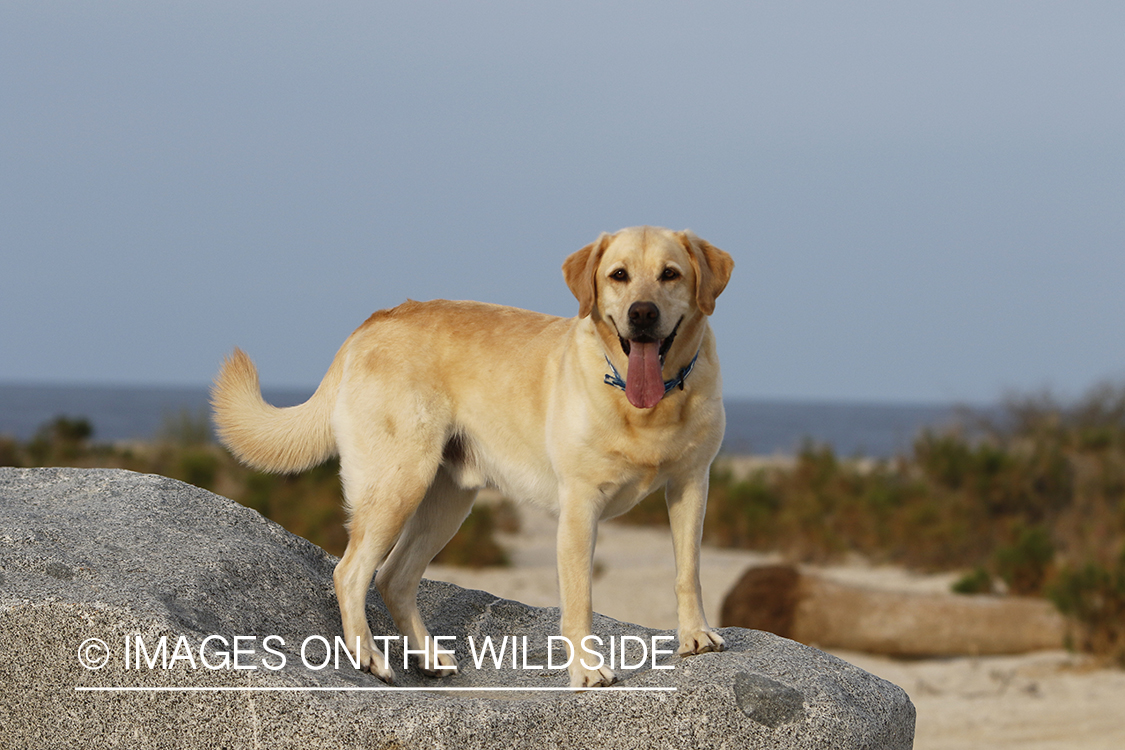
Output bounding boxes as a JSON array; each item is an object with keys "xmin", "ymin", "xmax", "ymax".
[{"xmin": 0, "ymin": 385, "xmax": 957, "ymax": 458}]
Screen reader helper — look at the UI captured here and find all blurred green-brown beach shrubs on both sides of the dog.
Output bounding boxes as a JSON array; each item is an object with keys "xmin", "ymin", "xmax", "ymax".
[{"xmin": 0, "ymin": 386, "xmax": 1125, "ymax": 661}]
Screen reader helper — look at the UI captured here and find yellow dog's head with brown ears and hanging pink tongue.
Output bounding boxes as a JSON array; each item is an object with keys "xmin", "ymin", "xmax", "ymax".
[{"xmin": 563, "ymin": 227, "xmax": 735, "ymax": 408}]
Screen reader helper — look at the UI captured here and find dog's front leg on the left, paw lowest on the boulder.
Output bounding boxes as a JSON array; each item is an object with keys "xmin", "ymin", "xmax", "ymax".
[{"xmin": 558, "ymin": 494, "xmax": 615, "ymax": 687}]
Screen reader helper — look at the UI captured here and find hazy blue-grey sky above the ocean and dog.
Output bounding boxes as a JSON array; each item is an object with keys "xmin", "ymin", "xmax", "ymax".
[{"xmin": 0, "ymin": 0, "xmax": 1125, "ymax": 401}]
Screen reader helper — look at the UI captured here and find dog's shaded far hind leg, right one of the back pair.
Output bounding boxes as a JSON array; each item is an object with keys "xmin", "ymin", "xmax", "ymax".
[{"xmin": 375, "ymin": 468, "xmax": 477, "ymax": 676}]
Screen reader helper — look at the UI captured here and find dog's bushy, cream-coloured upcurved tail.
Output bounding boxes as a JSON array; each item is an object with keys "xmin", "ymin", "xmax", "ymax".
[{"xmin": 212, "ymin": 349, "xmax": 343, "ymax": 473}]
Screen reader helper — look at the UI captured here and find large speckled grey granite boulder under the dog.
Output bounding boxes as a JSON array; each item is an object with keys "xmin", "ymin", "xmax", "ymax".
[{"xmin": 0, "ymin": 469, "xmax": 915, "ymax": 749}]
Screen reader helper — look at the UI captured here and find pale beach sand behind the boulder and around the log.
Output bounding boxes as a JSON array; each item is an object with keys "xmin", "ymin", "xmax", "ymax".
[{"xmin": 426, "ymin": 494, "xmax": 1125, "ymax": 750}]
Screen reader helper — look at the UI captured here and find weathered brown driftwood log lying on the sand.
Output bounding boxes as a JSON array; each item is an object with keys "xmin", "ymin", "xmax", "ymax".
[{"xmin": 720, "ymin": 566, "xmax": 1067, "ymax": 657}]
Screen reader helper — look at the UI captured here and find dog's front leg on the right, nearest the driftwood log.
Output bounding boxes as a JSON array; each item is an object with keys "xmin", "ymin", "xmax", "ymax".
[{"xmin": 665, "ymin": 470, "xmax": 723, "ymax": 656}]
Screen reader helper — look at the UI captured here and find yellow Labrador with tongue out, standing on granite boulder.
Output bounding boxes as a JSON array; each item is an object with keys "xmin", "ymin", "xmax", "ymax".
[{"xmin": 212, "ymin": 227, "xmax": 734, "ymax": 687}]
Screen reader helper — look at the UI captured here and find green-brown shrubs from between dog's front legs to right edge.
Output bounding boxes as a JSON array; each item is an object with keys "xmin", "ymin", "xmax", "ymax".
[{"xmin": 622, "ymin": 386, "xmax": 1125, "ymax": 661}]
